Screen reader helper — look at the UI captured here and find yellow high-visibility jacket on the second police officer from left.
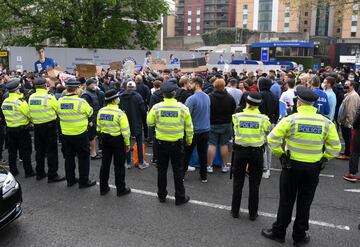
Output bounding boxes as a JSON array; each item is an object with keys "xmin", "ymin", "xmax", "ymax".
[{"xmin": 29, "ymin": 88, "xmax": 58, "ymax": 124}]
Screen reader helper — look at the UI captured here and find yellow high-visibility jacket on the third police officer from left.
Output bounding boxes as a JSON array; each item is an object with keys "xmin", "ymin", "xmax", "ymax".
[{"xmin": 57, "ymin": 94, "xmax": 93, "ymax": 136}]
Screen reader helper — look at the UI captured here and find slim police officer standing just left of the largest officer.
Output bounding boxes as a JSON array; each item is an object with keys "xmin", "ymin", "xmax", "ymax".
[{"xmin": 231, "ymin": 92, "xmax": 271, "ymax": 220}]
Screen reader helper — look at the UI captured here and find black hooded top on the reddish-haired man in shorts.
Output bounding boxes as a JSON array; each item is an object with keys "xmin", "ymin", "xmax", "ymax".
[{"xmin": 209, "ymin": 90, "xmax": 236, "ymax": 125}]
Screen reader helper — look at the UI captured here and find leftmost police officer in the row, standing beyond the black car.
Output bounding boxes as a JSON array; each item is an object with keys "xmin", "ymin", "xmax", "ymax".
[{"xmin": 1, "ymin": 79, "xmax": 35, "ymax": 177}]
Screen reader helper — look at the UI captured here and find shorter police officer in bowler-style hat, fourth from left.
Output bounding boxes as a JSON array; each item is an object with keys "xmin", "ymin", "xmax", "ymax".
[{"xmin": 97, "ymin": 89, "xmax": 131, "ymax": 196}]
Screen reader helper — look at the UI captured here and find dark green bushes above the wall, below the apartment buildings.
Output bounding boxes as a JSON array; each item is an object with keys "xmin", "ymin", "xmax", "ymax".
[{"xmin": 202, "ymin": 28, "xmax": 255, "ymax": 46}]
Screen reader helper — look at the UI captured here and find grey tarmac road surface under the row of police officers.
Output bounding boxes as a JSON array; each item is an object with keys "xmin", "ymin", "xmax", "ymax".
[{"xmin": 0, "ymin": 145, "xmax": 360, "ymax": 247}]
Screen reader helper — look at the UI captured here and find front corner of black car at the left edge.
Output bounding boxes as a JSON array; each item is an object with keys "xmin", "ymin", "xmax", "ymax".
[{"xmin": 0, "ymin": 166, "xmax": 22, "ymax": 230}]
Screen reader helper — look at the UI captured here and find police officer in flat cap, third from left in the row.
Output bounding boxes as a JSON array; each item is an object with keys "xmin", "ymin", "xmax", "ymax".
[{"xmin": 57, "ymin": 79, "xmax": 96, "ymax": 188}]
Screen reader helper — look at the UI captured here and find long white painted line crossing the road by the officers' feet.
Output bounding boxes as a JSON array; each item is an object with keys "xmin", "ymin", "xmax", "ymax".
[{"xmin": 96, "ymin": 183, "xmax": 350, "ymax": 231}]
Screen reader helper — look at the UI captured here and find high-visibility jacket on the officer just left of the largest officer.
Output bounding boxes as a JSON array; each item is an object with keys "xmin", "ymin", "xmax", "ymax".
[{"xmin": 232, "ymin": 108, "xmax": 271, "ymax": 147}]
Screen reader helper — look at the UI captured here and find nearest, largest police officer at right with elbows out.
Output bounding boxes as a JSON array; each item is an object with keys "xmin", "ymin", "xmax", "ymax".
[{"xmin": 262, "ymin": 86, "xmax": 341, "ymax": 246}]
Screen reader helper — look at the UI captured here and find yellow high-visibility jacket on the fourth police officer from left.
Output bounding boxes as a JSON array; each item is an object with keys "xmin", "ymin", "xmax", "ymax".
[{"xmin": 96, "ymin": 104, "xmax": 130, "ymax": 146}]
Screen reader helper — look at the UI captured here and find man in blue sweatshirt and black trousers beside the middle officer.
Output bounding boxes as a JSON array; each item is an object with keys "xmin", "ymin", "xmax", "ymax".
[{"xmin": 184, "ymin": 76, "xmax": 210, "ymax": 183}]
